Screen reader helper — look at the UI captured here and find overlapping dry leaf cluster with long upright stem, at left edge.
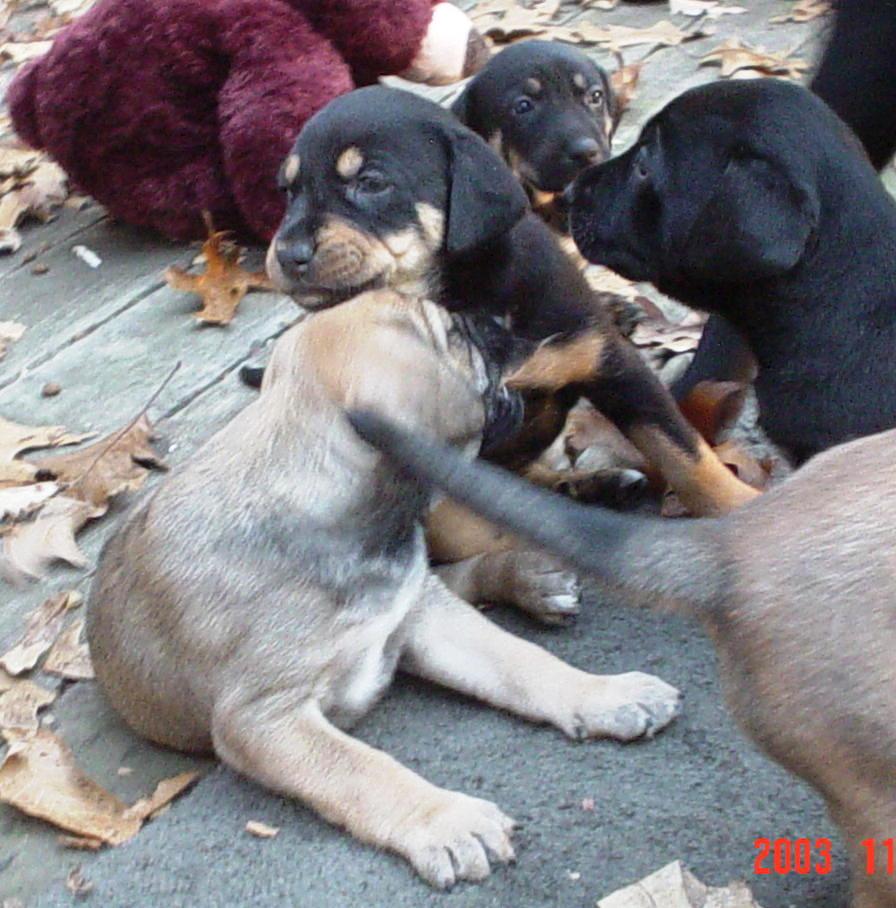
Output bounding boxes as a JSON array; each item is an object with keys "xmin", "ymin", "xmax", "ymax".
[{"xmin": 0, "ymin": 415, "xmax": 164, "ymax": 584}]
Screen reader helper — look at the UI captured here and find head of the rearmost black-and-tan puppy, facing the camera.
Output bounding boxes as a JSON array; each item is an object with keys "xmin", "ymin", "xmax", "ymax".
[{"xmin": 452, "ymin": 41, "xmax": 616, "ymax": 193}]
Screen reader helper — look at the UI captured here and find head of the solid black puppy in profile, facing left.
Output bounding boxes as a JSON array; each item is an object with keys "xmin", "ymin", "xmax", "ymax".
[{"xmin": 568, "ymin": 79, "xmax": 824, "ymax": 298}]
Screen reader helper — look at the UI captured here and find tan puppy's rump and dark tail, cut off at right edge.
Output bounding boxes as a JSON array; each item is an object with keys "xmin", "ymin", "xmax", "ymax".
[{"xmin": 350, "ymin": 413, "xmax": 896, "ymax": 908}]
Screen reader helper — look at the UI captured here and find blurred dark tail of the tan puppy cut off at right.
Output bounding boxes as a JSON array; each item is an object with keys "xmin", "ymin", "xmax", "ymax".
[{"xmin": 348, "ymin": 410, "xmax": 724, "ymax": 615}]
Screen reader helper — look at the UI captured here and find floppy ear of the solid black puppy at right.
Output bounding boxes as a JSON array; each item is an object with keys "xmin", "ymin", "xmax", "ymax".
[{"xmin": 683, "ymin": 156, "xmax": 819, "ymax": 283}]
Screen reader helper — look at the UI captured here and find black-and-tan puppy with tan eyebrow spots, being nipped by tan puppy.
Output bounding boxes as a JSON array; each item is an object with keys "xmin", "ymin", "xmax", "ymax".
[{"xmin": 268, "ymin": 86, "xmax": 752, "ymax": 513}]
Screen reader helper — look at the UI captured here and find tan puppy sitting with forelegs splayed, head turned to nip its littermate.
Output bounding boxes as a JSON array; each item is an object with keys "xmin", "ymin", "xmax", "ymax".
[{"xmin": 88, "ymin": 291, "xmax": 678, "ymax": 887}]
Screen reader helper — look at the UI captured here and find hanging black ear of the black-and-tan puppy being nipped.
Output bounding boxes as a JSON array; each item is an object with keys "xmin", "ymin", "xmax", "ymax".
[{"xmin": 445, "ymin": 129, "xmax": 529, "ymax": 255}]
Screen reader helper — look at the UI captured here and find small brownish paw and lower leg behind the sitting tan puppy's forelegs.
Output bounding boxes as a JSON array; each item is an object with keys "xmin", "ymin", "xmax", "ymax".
[{"xmin": 433, "ymin": 549, "xmax": 581, "ymax": 624}]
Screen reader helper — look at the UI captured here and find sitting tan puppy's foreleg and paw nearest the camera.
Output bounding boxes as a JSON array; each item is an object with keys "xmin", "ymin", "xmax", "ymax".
[{"xmin": 212, "ymin": 691, "xmax": 514, "ymax": 889}]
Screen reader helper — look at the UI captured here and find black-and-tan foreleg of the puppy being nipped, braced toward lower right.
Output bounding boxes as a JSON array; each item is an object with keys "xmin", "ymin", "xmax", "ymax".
[{"xmin": 507, "ymin": 327, "xmax": 759, "ymax": 516}]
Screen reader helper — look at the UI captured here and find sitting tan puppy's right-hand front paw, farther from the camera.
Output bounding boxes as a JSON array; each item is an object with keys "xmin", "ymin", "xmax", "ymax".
[{"xmin": 561, "ymin": 672, "xmax": 681, "ymax": 741}]
